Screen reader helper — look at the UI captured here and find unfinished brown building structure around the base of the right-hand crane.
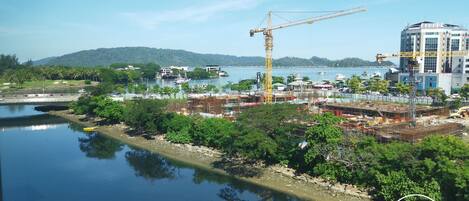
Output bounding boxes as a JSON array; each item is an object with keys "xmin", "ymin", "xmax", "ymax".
[{"xmin": 323, "ymin": 101, "xmax": 464, "ymax": 142}]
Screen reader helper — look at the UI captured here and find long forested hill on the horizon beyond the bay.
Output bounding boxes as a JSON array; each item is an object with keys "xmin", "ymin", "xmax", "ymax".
[{"xmin": 34, "ymin": 47, "xmax": 393, "ymax": 67}]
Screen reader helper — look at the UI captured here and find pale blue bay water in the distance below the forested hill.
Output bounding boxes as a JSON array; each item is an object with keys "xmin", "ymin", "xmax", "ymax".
[{"xmin": 157, "ymin": 66, "xmax": 389, "ymax": 86}]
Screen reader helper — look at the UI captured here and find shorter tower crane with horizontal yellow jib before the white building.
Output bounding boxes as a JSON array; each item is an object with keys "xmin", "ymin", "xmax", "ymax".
[{"xmin": 376, "ymin": 51, "xmax": 469, "ymax": 126}]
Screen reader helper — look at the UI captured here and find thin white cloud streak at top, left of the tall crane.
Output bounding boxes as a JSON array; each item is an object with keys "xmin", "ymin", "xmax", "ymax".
[{"xmin": 122, "ymin": 0, "xmax": 260, "ymax": 29}]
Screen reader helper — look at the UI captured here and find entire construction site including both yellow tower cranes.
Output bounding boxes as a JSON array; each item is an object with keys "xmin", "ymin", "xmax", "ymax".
[{"xmin": 175, "ymin": 8, "xmax": 469, "ymax": 142}]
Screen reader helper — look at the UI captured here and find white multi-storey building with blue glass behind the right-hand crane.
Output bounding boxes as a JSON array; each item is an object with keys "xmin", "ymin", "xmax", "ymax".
[{"xmin": 397, "ymin": 21, "xmax": 469, "ymax": 94}]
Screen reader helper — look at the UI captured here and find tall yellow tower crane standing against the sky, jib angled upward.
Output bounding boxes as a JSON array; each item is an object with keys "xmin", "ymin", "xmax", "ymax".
[{"xmin": 249, "ymin": 7, "xmax": 366, "ymax": 103}]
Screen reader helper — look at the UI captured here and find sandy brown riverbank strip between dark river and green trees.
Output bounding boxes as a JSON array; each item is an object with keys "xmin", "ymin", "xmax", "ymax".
[{"xmin": 49, "ymin": 111, "xmax": 370, "ymax": 201}]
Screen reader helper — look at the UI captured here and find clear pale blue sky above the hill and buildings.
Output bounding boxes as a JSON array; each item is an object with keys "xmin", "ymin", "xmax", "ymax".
[{"xmin": 0, "ymin": 0, "xmax": 469, "ymax": 61}]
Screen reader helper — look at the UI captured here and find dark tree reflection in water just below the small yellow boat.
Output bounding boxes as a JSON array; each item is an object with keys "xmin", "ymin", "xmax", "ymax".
[{"xmin": 78, "ymin": 133, "xmax": 124, "ymax": 159}]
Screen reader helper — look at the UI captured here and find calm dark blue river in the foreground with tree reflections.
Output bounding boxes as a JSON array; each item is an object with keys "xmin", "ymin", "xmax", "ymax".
[{"xmin": 0, "ymin": 106, "xmax": 297, "ymax": 201}]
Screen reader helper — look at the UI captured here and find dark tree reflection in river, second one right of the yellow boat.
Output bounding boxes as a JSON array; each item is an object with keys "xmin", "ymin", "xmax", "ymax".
[{"xmin": 125, "ymin": 149, "xmax": 177, "ymax": 181}]
